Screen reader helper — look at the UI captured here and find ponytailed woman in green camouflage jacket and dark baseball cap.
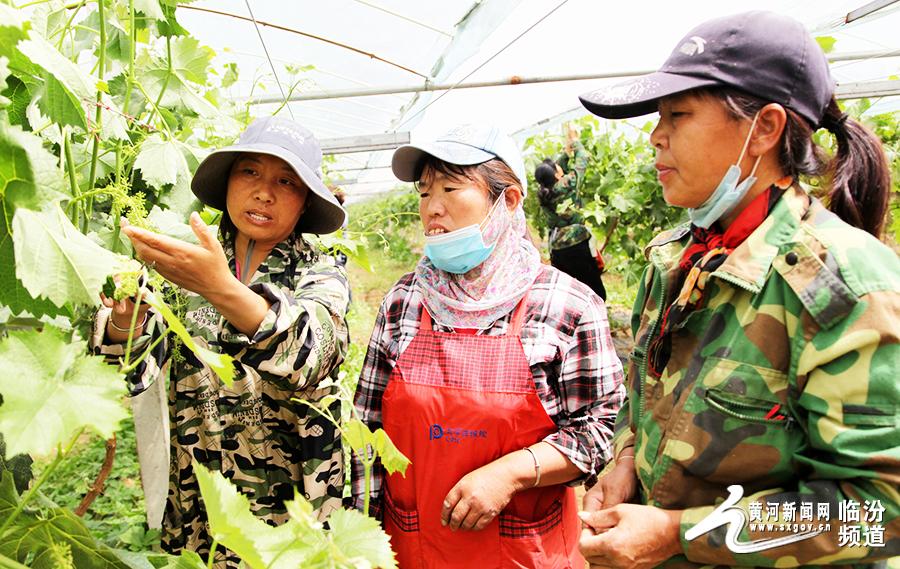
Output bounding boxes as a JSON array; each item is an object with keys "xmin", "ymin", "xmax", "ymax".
[{"xmin": 581, "ymin": 12, "xmax": 900, "ymax": 568}]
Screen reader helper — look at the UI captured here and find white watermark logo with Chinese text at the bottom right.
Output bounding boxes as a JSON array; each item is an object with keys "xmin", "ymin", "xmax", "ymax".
[{"xmin": 684, "ymin": 485, "xmax": 884, "ymax": 553}]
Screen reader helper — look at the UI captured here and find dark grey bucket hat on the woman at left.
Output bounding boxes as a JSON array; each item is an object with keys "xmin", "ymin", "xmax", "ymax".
[{"xmin": 191, "ymin": 117, "xmax": 347, "ymax": 233}]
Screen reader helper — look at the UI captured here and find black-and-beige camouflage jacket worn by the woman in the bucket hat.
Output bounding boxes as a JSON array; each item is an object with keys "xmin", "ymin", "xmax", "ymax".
[{"xmin": 92, "ymin": 230, "xmax": 349, "ymax": 567}]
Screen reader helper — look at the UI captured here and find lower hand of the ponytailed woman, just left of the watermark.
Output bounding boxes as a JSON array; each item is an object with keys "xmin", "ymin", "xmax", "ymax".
[{"xmin": 578, "ymin": 504, "xmax": 682, "ymax": 569}]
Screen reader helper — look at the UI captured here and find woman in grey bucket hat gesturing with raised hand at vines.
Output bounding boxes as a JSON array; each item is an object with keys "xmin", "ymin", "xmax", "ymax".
[{"xmin": 94, "ymin": 117, "xmax": 349, "ymax": 568}]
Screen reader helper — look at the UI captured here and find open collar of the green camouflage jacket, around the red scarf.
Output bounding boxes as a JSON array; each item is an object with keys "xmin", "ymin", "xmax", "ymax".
[{"xmin": 644, "ymin": 185, "xmax": 810, "ymax": 294}]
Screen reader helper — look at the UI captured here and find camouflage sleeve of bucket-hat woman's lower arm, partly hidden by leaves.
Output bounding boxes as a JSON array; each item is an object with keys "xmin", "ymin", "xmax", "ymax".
[{"xmin": 88, "ymin": 307, "xmax": 171, "ymax": 395}]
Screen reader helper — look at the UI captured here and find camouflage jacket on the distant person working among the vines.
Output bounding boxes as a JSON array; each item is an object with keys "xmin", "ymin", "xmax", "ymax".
[{"xmin": 544, "ymin": 141, "xmax": 591, "ymax": 250}]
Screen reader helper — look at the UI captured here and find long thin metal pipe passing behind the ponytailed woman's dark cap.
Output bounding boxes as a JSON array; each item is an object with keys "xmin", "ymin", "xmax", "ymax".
[{"xmin": 243, "ymin": 49, "xmax": 900, "ymax": 105}]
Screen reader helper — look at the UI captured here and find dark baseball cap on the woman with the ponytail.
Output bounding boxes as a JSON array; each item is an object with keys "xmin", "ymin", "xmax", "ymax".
[{"xmin": 579, "ymin": 11, "xmax": 834, "ymax": 126}]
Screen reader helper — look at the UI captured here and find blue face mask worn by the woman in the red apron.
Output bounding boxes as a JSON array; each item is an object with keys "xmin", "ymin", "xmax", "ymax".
[{"xmin": 425, "ymin": 196, "xmax": 506, "ymax": 275}]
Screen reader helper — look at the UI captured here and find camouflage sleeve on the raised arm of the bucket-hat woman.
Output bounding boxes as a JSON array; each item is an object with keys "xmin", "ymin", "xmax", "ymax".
[{"xmin": 219, "ymin": 256, "xmax": 350, "ymax": 389}]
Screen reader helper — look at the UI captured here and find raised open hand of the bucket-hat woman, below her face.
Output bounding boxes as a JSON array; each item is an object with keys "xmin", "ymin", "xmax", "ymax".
[{"xmin": 122, "ymin": 212, "xmax": 233, "ymax": 296}]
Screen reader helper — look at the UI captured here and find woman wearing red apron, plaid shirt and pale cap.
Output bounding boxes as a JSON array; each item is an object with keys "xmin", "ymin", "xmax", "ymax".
[{"xmin": 353, "ymin": 125, "xmax": 624, "ymax": 569}]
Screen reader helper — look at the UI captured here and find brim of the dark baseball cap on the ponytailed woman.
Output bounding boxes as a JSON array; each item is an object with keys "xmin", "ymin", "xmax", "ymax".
[{"xmin": 578, "ymin": 71, "xmax": 721, "ymax": 119}]
